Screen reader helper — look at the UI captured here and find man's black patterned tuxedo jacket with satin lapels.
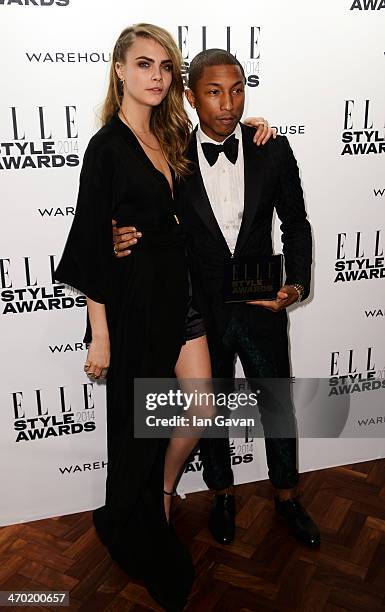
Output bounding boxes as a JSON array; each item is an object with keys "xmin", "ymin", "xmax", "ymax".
[{"xmin": 180, "ymin": 124, "xmax": 312, "ymax": 338}]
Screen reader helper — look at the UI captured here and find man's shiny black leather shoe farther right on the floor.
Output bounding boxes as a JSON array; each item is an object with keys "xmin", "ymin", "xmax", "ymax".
[{"xmin": 274, "ymin": 496, "xmax": 321, "ymax": 548}]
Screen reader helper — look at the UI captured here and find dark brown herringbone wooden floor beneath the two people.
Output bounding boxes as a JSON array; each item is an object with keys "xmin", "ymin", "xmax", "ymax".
[{"xmin": 0, "ymin": 460, "xmax": 385, "ymax": 612}]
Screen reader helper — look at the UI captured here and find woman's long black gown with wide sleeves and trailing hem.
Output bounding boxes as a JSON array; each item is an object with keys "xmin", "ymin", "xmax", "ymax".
[{"xmin": 56, "ymin": 116, "xmax": 196, "ymax": 609}]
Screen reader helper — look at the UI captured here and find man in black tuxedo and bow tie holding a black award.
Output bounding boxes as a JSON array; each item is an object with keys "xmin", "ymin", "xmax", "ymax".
[{"xmin": 114, "ymin": 49, "xmax": 320, "ymax": 547}]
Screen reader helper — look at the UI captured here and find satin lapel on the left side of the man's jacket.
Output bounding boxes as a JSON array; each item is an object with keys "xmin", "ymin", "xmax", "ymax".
[{"xmin": 187, "ymin": 128, "xmax": 230, "ymax": 254}]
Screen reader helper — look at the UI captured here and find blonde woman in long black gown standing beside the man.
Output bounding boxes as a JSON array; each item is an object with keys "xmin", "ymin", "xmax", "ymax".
[{"xmin": 56, "ymin": 24, "xmax": 211, "ymax": 610}]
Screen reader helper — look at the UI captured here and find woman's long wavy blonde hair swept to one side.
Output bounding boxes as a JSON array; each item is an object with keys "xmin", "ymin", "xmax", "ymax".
[{"xmin": 101, "ymin": 23, "xmax": 191, "ymax": 177}]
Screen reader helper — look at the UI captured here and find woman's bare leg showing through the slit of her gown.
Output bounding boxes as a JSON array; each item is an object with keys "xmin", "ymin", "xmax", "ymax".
[{"xmin": 164, "ymin": 336, "xmax": 211, "ymax": 520}]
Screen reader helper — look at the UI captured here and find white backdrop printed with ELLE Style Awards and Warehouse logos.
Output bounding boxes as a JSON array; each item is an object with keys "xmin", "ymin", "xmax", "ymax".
[{"xmin": 0, "ymin": 0, "xmax": 385, "ymax": 525}]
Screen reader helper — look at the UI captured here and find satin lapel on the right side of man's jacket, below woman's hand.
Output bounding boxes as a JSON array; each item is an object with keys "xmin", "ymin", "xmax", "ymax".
[{"xmin": 234, "ymin": 124, "xmax": 263, "ymax": 255}]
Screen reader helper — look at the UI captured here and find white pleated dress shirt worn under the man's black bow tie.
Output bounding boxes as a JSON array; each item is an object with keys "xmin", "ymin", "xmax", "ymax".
[{"xmin": 197, "ymin": 123, "xmax": 245, "ymax": 253}]
